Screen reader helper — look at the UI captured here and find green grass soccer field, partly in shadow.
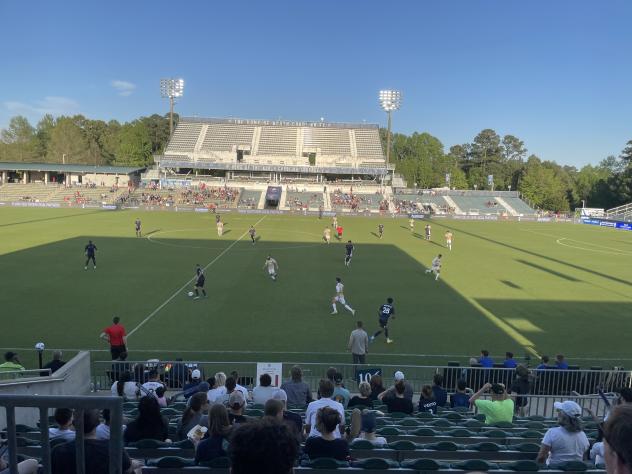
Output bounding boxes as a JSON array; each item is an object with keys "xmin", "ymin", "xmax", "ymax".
[{"xmin": 0, "ymin": 208, "xmax": 632, "ymax": 367}]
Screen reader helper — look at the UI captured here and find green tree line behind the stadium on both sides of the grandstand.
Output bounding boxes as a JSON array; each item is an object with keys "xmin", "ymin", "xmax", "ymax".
[{"xmin": 0, "ymin": 114, "xmax": 632, "ymax": 211}]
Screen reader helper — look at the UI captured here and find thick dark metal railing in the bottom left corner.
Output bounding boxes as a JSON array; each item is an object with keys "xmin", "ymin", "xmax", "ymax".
[{"xmin": 0, "ymin": 395, "xmax": 123, "ymax": 474}]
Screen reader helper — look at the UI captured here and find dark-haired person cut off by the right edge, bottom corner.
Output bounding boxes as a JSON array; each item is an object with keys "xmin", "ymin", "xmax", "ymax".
[{"xmin": 603, "ymin": 404, "xmax": 632, "ymax": 474}]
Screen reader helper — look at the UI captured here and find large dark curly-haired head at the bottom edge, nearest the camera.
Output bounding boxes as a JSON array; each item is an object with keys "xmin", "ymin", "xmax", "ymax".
[{"xmin": 229, "ymin": 419, "xmax": 299, "ymax": 474}]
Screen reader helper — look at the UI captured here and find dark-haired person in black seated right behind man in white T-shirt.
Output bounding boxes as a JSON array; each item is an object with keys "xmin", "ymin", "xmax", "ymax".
[{"xmin": 303, "ymin": 407, "xmax": 349, "ymax": 461}]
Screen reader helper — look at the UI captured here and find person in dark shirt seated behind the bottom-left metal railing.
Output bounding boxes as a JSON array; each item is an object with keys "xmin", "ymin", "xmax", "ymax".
[{"xmin": 51, "ymin": 408, "xmax": 136, "ymax": 474}]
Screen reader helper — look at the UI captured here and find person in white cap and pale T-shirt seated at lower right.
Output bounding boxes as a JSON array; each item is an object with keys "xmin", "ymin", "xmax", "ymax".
[{"xmin": 536, "ymin": 400, "xmax": 590, "ymax": 466}]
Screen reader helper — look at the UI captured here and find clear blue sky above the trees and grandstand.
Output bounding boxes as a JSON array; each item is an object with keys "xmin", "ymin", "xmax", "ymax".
[{"xmin": 0, "ymin": 0, "xmax": 632, "ymax": 166}]
